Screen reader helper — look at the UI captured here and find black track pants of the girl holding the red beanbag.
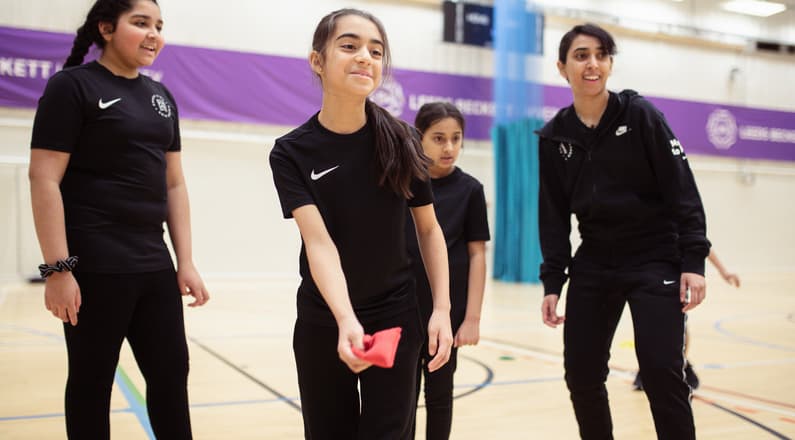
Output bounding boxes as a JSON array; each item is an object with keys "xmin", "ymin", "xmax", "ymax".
[{"xmin": 293, "ymin": 309, "xmax": 424, "ymax": 440}]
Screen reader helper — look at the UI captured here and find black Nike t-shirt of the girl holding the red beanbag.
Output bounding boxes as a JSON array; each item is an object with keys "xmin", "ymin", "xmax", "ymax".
[{"xmin": 270, "ymin": 114, "xmax": 433, "ymax": 325}]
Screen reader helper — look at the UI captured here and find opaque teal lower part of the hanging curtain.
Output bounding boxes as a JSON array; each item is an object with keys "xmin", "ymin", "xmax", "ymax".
[{"xmin": 492, "ymin": 118, "xmax": 543, "ymax": 282}]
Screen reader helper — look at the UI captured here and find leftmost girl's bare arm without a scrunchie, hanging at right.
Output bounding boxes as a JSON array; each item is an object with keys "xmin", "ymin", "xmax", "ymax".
[{"xmin": 166, "ymin": 151, "xmax": 210, "ymax": 307}]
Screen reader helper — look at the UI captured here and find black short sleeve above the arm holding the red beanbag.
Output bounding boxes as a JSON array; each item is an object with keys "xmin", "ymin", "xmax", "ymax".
[{"xmin": 270, "ymin": 141, "xmax": 315, "ymax": 218}]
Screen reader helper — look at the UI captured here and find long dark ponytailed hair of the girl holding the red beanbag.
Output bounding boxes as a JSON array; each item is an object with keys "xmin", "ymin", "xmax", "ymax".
[{"xmin": 312, "ymin": 8, "xmax": 431, "ymax": 198}]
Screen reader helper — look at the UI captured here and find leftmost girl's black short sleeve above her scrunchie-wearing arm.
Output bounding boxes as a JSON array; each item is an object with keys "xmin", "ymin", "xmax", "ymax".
[{"xmin": 30, "ymin": 71, "xmax": 84, "ymax": 153}]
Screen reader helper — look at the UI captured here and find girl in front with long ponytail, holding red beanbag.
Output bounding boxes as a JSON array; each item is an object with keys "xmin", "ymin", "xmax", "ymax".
[{"xmin": 270, "ymin": 9, "xmax": 453, "ymax": 440}]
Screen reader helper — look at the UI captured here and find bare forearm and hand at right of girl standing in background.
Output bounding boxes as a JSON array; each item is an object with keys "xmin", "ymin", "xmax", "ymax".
[{"xmin": 454, "ymin": 241, "xmax": 486, "ymax": 347}]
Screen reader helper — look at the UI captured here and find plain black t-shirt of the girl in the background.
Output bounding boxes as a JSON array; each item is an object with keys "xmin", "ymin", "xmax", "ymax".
[{"xmin": 406, "ymin": 167, "xmax": 490, "ymax": 330}]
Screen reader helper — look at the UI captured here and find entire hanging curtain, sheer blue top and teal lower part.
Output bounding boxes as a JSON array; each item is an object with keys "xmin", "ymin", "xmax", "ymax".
[{"xmin": 492, "ymin": 0, "xmax": 544, "ymax": 283}]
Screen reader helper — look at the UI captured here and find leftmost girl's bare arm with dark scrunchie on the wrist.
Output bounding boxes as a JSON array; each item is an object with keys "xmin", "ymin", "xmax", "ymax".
[{"xmin": 28, "ymin": 148, "xmax": 81, "ymax": 325}]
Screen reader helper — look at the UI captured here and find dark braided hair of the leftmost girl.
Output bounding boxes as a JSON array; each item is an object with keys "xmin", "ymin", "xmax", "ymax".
[{"xmin": 63, "ymin": 0, "xmax": 157, "ymax": 67}]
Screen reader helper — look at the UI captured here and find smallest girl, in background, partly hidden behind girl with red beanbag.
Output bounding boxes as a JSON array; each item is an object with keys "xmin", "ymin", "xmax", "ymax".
[{"xmin": 406, "ymin": 102, "xmax": 490, "ymax": 440}]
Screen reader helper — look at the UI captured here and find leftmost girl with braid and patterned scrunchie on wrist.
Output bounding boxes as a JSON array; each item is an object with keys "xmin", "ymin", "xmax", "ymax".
[{"xmin": 30, "ymin": 0, "xmax": 209, "ymax": 440}]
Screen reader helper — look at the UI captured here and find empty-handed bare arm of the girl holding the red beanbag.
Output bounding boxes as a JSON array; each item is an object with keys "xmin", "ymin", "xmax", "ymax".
[{"xmin": 411, "ymin": 204, "xmax": 453, "ymax": 371}]
